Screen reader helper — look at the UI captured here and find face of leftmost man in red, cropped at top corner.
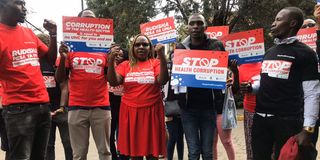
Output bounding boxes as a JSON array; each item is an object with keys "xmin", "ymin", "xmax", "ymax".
[{"xmin": 2, "ymin": 0, "xmax": 27, "ymax": 23}]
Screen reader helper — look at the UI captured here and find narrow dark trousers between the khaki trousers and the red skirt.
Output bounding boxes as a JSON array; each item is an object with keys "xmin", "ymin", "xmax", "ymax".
[{"xmin": 109, "ymin": 93, "xmax": 121, "ymax": 160}]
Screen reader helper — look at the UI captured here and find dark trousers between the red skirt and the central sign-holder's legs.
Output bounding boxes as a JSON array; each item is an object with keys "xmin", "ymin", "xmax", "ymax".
[{"xmin": 166, "ymin": 116, "xmax": 184, "ymax": 160}]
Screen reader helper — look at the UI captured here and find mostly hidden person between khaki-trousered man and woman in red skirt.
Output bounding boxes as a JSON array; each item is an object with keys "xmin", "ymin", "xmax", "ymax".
[{"xmin": 108, "ymin": 45, "xmax": 129, "ymax": 160}]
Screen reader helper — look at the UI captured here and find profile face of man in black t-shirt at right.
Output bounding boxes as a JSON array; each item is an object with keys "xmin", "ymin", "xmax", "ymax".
[{"xmin": 270, "ymin": 9, "xmax": 296, "ymax": 39}]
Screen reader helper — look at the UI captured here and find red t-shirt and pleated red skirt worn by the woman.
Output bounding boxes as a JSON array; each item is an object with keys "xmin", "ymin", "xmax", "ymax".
[{"xmin": 116, "ymin": 59, "xmax": 166, "ymax": 157}]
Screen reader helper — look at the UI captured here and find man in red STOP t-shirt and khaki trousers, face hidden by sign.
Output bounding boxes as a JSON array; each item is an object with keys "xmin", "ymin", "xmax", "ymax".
[{"xmin": 56, "ymin": 10, "xmax": 111, "ymax": 160}]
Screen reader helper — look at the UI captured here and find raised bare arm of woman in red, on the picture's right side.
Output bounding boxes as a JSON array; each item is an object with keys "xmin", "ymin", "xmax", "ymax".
[{"xmin": 155, "ymin": 44, "xmax": 169, "ymax": 85}]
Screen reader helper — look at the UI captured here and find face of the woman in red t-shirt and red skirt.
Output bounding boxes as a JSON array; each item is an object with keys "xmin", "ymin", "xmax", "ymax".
[{"xmin": 133, "ymin": 36, "xmax": 151, "ymax": 61}]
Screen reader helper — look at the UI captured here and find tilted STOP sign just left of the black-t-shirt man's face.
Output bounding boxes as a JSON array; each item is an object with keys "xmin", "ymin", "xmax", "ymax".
[{"xmin": 221, "ymin": 29, "xmax": 265, "ymax": 64}]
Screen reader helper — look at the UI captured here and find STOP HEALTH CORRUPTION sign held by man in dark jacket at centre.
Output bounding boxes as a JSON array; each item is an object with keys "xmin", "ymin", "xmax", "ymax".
[{"xmin": 171, "ymin": 49, "xmax": 228, "ymax": 89}]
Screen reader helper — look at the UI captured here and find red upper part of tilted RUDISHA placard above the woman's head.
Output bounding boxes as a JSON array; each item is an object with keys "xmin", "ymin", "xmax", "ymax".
[{"xmin": 140, "ymin": 17, "xmax": 175, "ymax": 36}]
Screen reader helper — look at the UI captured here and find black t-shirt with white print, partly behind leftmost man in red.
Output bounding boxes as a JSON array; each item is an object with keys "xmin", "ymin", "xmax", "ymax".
[{"xmin": 40, "ymin": 59, "xmax": 61, "ymax": 111}]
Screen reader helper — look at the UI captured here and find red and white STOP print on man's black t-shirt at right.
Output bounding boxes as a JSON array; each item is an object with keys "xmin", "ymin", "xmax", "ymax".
[{"xmin": 261, "ymin": 60, "xmax": 292, "ymax": 79}]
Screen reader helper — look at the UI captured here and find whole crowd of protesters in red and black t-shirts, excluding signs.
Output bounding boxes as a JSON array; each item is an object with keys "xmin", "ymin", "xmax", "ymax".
[{"xmin": 0, "ymin": 0, "xmax": 320, "ymax": 160}]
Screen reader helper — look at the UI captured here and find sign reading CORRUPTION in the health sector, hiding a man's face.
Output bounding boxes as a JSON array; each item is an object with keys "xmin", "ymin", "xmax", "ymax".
[{"xmin": 63, "ymin": 17, "xmax": 113, "ymax": 52}]
